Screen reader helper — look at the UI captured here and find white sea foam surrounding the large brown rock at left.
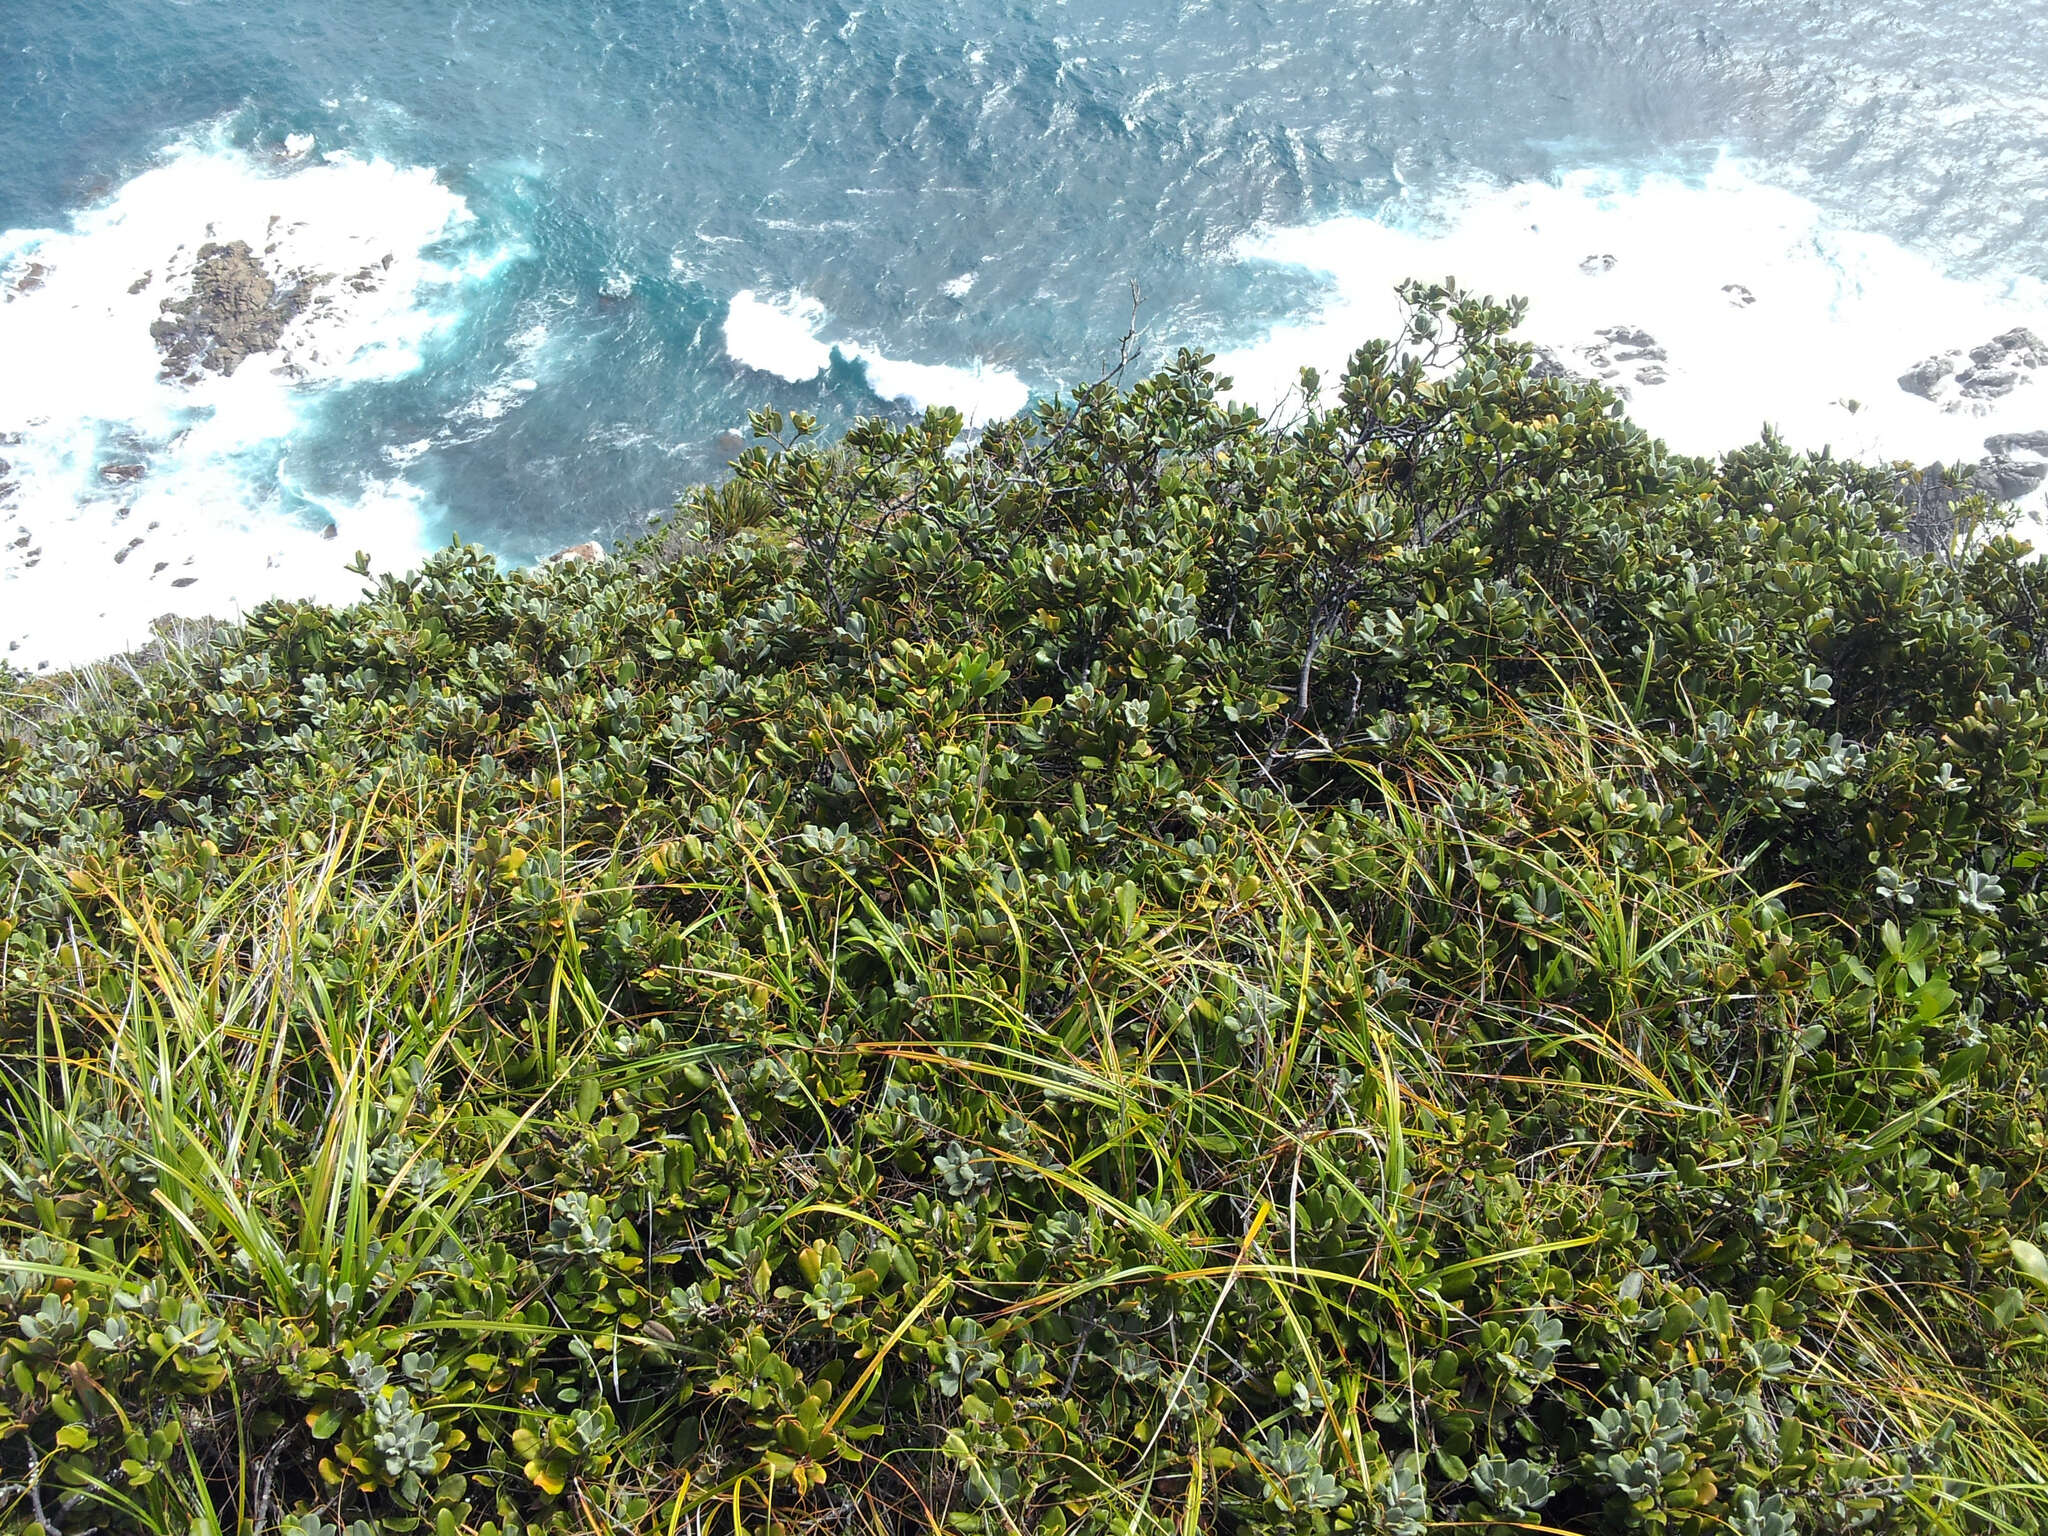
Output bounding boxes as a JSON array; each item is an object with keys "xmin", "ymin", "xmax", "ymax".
[{"xmin": 0, "ymin": 120, "xmax": 496, "ymax": 668}]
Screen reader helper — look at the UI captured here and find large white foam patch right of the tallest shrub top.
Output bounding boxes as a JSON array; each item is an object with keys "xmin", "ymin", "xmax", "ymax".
[{"xmin": 1217, "ymin": 158, "xmax": 2048, "ymax": 532}]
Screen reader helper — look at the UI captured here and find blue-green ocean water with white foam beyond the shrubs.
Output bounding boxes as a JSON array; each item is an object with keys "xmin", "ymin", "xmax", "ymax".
[{"xmin": 0, "ymin": 0, "xmax": 2048, "ymax": 668}]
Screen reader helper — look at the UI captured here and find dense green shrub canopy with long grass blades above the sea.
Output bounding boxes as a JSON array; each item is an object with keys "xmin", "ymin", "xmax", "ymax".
[{"xmin": 0, "ymin": 287, "xmax": 2048, "ymax": 1536}]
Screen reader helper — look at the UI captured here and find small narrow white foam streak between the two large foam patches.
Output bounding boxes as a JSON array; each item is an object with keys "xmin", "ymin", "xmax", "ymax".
[{"xmin": 725, "ymin": 289, "xmax": 1030, "ymax": 426}]
